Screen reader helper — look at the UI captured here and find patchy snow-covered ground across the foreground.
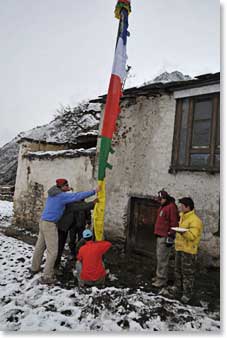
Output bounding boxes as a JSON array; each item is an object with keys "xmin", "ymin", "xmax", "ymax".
[{"xmin": 0, "ymin": 234, "xmax": 220, "ymax": 333}]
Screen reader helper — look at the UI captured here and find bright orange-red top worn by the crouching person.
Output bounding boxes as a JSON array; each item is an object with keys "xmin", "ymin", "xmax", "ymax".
[{"xmin": 77, "ymin": 241, "xmax": 112, "ymax": 281}]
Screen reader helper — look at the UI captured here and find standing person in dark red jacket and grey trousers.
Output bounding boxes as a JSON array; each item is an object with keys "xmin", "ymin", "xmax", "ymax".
[{"xmin": 152, "ymin": 190, "xmax": 179, "ymax": 288}]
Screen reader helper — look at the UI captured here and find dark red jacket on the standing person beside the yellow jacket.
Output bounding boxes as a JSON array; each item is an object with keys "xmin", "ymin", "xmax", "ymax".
[{"xmin": 154, "ymin": 202, "xmax": 179, "ymax": 237}]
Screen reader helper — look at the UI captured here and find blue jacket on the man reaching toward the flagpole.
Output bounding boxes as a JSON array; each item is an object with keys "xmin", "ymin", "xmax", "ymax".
[{"xmin": 41, "ymin": 185, "xmax": 96, "ymax": 223}]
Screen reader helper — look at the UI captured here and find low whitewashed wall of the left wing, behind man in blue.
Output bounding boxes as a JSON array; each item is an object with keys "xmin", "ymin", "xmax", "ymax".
[{"xmin": 13, "ymin": 143, "xmax": 96, "ymax": 232}]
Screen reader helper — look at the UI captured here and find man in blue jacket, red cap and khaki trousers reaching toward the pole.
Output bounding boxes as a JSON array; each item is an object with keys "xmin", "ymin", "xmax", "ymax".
[{"xmin": 31, "ymin": 178, "xmax": 99, "ymax": 284}]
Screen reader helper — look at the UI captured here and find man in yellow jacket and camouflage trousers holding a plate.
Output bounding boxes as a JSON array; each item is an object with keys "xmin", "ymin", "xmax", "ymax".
[{"xmin": 168, "ymin": 197, "xmax": 203, "ymax": 304}]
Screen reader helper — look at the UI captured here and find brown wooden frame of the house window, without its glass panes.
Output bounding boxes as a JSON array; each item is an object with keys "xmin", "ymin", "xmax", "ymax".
[{"xmin": 169, "ymin": 93, "xmax": 220, "ymax": 173}]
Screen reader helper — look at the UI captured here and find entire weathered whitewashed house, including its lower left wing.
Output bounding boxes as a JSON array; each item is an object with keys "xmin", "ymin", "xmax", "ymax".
[{"xmin": 14, "ymin": 73, "xmax": 220, "ymax": 265}]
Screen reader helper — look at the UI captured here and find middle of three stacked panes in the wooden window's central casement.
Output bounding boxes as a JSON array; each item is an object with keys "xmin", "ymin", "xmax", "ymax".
[{"xmin": 192, "ymin": 120, "xmax": 211, "ymax": 147}]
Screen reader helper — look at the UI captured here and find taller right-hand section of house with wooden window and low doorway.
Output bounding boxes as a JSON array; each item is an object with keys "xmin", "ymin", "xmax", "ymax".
[{"xmin": 92, "ymin": 73, "xmax": 220, "ymax": 265}]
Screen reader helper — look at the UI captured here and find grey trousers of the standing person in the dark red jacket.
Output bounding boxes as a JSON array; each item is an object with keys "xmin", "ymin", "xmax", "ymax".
[{"xmin": 156, "ymin": 237, "xmax": 171, "ymax": 282}]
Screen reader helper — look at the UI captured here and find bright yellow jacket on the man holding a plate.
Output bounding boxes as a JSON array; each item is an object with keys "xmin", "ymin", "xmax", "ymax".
[{"xmin": 175, "ymin": 210, "xmax": 203, "ymax": 255}]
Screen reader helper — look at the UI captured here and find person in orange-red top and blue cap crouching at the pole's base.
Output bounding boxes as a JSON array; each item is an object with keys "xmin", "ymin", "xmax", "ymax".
[{"xmin": 76, "ymin": 229, "xmax": 112, "ymax": 286}]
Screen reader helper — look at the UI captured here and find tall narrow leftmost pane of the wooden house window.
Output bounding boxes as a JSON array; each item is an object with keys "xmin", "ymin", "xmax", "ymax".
[{"xmin": 179, "ymin": 99, "xmax": 189, "ymax": 164}]
